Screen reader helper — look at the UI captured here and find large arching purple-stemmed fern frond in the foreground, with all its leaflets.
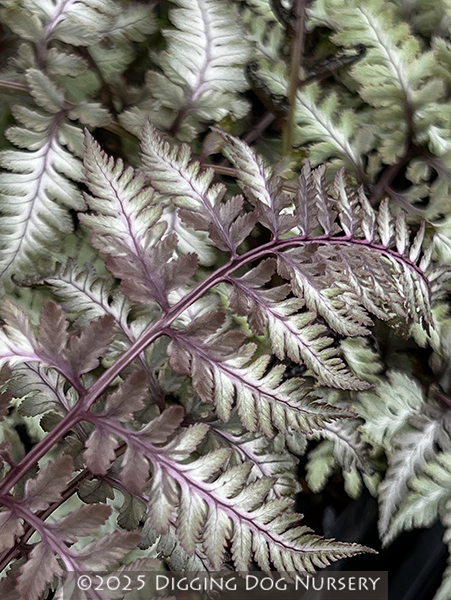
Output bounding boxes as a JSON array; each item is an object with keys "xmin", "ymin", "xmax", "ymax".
[{"xmin": 0, "ymin": 123, "xmax": 434, "ymax": 600}]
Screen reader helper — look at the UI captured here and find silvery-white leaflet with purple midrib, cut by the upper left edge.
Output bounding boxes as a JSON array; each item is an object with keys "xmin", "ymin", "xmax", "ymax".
[{"xmin": 0, "ymin": 98, "xmax": 84, "ymax": 283}]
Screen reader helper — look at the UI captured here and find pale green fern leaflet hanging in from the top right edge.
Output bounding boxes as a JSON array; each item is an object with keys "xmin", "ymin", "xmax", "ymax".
[{"xmin": 309, "ymin": 0, "xmax": 443, "ymax": 164}]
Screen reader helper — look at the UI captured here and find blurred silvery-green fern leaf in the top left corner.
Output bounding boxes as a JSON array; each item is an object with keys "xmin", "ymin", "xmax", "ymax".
[{"xmin": 2, "ymin": 0, "xmax": 155, "ymax": 94}]
